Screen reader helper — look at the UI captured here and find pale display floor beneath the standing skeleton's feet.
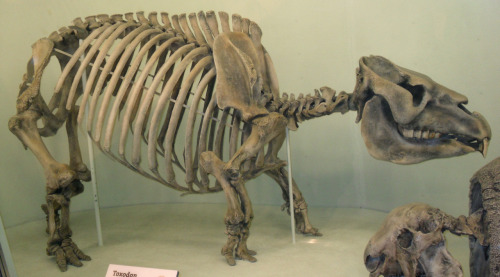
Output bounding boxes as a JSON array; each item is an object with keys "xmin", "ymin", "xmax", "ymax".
[{"xmin": 6, "ymin": 203, "xmax": 469, "ymax": 277}]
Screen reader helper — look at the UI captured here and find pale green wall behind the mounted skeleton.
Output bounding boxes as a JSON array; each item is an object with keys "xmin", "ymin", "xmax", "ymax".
[{"xmin": 0, "ymin": 0, "xmax": 500, "ymax": 226}]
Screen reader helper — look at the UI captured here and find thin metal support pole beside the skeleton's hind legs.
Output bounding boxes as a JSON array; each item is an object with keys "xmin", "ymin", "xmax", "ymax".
[{"xmin": 80, "ymin": 40, "xmax": 103, "ymax": 246}]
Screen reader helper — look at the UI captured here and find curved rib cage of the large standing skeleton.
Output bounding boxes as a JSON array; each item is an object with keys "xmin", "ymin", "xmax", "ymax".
[{"xmin": 50, "ymin": 12, "xmax": 262, "ymax": 193}]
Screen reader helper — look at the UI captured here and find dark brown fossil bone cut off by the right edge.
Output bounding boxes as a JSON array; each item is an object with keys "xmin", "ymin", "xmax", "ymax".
[{"xmin": 469, "ymin": 157, "xmax": 500, "ymax": 277}]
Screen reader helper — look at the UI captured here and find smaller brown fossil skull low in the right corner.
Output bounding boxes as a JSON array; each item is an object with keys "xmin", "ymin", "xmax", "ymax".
[{"xmin": 364, "ymin": 203, "xmax": 472, "ymax": 277}]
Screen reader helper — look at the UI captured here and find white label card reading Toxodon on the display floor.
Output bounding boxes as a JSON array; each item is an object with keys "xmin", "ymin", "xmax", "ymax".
[{"xmin": 106, "ymin": 264, "xmax": 179, "ymax": 277}]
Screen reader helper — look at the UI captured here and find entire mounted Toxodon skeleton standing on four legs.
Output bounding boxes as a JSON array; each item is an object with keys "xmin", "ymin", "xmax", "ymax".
[{"xmin": 9, "ymin": 12, "xmax": 491, "ymax": 271}]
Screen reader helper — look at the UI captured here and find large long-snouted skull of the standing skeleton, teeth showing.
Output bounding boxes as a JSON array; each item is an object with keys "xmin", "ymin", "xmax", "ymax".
[{"xmin": 353, "ymin": 56, "xmax": 491, "ymax": 164}]
